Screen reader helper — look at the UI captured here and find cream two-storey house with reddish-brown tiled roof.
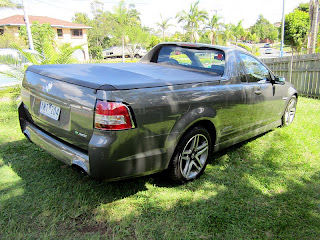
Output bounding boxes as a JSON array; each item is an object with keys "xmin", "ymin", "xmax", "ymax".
[{"xmin": 0, "ymin": 15, "xmax": 91, "ymax": 60}]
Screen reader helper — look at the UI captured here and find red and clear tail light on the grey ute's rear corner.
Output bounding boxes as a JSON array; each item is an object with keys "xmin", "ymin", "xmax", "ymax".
[{"xmin": 94, "ymin": 100, "xmax": 134, "ymax": 130}]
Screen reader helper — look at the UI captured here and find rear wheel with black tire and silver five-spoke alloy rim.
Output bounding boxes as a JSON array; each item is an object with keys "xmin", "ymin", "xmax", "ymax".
[{"xmin": 168, "ymin": 126, "xmax": 212, "ymax": 183}]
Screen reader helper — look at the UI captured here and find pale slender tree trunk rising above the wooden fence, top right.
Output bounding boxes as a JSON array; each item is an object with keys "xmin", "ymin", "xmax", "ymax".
[{"xmin": 308, "ymin": 0, "xmax": 319, "ymax": 54}]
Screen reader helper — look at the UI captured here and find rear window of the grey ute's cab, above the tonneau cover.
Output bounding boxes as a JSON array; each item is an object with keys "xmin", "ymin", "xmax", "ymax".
[{"xmin": 157, "ymin": 46, "xmax": 225, "ymax": 76}]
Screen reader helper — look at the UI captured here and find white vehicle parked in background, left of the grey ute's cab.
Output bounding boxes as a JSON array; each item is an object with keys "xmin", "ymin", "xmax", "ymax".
[{"xmin": 102, "ymin": 45, "xmax": 148, "ymax": 59}]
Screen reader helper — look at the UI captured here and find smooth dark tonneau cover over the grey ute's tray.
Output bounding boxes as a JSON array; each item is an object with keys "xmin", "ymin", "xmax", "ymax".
[{"xmin": 28, "ymin": 63, "xmax": 220, "ymax": 90}]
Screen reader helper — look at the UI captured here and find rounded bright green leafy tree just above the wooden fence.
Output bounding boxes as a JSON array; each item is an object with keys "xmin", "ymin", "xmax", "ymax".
[{"xmin": 284, "ymin": 9, "xmax": 310, "ymax": 54}]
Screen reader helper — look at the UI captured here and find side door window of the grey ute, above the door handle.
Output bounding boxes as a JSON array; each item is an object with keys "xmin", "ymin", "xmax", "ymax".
[{"xmin": 239, "ymin": 53, "xmax": 270, "ymax": 82}]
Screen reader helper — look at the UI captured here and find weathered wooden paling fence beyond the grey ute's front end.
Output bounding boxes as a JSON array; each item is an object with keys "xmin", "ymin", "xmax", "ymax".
[{"xmin": 262, "ymin": 53, "xmax": 320, "ymax": 98}]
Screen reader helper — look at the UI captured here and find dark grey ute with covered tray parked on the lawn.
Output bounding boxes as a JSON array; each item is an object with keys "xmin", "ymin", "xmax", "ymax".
[{"xmin": 19, "ymin": 43, "xmax": 298, "ymax": 183}]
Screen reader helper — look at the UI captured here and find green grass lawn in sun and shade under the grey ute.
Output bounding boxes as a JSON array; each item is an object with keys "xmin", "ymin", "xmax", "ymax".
[{"xmin": 0, "ymin": 91, "xmax": 320, "ymax": 240}]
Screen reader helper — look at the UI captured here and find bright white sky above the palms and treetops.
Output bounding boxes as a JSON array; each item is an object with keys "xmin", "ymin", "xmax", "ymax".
[{"xmin": 0, "ymin": 0, "xmax": 309, "ymax": 32}]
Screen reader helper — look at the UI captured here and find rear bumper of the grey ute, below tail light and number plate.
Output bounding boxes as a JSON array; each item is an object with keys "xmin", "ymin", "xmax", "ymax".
[{"xmin": 19, "ymin": 103, "xmax": 169, "ymax": 180}]
